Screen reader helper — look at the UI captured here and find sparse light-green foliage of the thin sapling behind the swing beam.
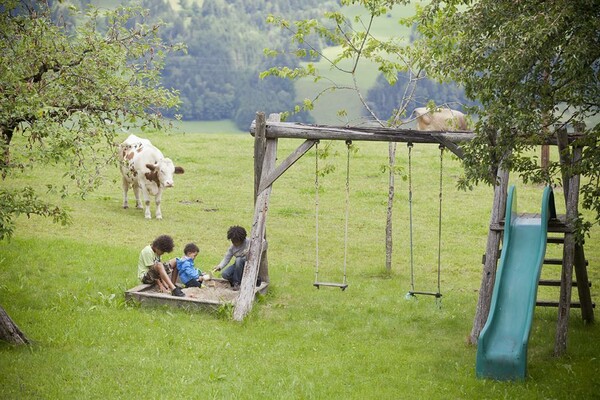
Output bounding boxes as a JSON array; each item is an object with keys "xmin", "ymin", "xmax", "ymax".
[{"xmin": 261, "ymin": 0, "xmax": 422, "ymax": 125}]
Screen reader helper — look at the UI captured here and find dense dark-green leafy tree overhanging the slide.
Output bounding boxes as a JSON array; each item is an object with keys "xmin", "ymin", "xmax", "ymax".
[{"xmin": 414, "ymin": 0, "xmax": 600, "ymax": 343}]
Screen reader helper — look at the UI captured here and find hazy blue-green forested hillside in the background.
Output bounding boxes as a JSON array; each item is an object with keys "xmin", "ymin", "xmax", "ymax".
[{"xmin": 51, "ymin": 0, "xmax": 474, "ymax": 130}]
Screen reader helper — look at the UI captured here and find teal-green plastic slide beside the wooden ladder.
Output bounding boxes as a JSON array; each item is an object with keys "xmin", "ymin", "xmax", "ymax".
[{"xmin": 475, "ymin": 186, "xmax": 556, "ymax": 380}]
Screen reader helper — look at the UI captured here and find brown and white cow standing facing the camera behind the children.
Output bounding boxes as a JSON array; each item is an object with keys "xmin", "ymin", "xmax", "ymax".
[{"xmin": 119, "ymin": 135, "xmax": 183, "ymax": 219}]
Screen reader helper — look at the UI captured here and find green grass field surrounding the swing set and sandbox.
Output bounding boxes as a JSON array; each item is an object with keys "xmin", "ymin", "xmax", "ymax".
[{"xmin": 0, "ymin": 129, "xmax": 600, "ymax": 399}]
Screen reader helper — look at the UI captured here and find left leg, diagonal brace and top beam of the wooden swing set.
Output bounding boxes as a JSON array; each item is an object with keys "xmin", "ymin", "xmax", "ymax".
[{"xmin": 233, "ymin": 113, "xmax": 473, "ymax": 321}]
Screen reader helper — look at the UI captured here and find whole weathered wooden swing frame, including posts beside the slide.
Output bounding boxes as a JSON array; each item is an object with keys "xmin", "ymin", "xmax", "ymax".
[{"xmin": 233, "ymin": 112, "xmax": 593, "ymax": 354}]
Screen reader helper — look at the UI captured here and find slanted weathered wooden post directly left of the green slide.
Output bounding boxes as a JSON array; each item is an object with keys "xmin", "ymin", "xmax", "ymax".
[{"xmin": 469, "ymin": 169, "xmax": 508, "ymax": 344}]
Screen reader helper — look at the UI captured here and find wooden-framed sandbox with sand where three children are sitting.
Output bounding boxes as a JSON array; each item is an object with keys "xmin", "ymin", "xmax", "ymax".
[{"xmin": 125, "ymin": 279, "xmax": 269, "ymax": 310}]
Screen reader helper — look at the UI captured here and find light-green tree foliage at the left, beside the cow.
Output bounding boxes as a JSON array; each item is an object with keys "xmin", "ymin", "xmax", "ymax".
[{"xmin": 0, "ymin": 0, "xmax": 181, "ymax": 239}]
